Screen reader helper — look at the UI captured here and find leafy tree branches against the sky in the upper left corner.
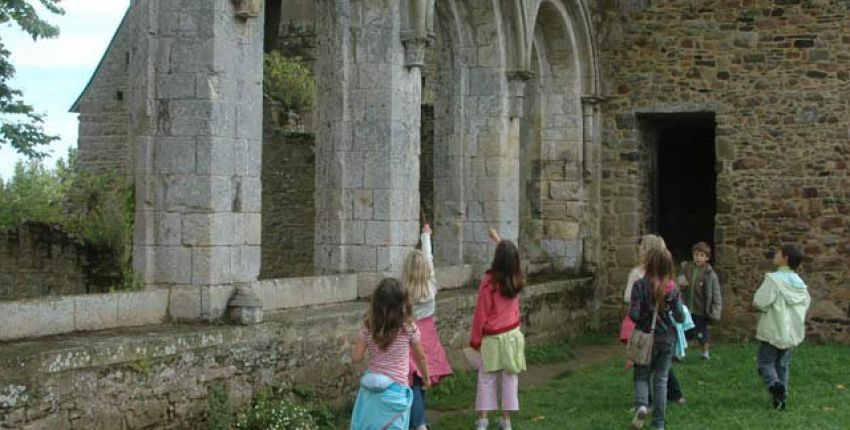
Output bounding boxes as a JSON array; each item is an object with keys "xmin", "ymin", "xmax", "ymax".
[{"xmin": 0, "ymin": 0, "xmax": 65, "ymax": 158}]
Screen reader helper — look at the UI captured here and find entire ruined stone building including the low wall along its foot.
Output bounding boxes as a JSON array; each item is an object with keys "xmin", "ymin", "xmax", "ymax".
[{"xmin": 0, "ymin": 0, "xmax": 850, "ymax": 428}]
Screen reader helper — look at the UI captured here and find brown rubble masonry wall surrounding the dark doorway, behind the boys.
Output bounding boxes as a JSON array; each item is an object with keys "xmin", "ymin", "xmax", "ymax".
[{"xmin": 597, "ymin": 0, "xmax": 850, "ymax": 338}]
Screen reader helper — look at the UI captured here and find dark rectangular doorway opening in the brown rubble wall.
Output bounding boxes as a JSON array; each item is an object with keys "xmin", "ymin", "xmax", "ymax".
[{"xmin": 641, "ymin": 113, "xmax": 717, "ymax": 261}]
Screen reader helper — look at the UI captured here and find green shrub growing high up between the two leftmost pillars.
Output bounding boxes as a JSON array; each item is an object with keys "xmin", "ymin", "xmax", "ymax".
[{"xmin": 263, "ymin": 52, "xmax": 316, "ymax": 112}]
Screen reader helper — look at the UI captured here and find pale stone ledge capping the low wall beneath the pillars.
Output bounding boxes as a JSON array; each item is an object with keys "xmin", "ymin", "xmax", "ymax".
[{"xmin": 0, "ymin": 278, "xmax": 592, "ymax": 383}]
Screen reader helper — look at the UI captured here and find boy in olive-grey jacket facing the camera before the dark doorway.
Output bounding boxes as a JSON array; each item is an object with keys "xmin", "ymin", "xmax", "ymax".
[{"xmin": 679, "ymin": 242, "xmax": 723, "ymax": 360}]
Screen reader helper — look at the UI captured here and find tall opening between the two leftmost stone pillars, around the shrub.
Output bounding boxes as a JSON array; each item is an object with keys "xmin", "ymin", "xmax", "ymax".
[{"xmin": 259, "ymin": 0, "xmax": 316, "ymax": 279}]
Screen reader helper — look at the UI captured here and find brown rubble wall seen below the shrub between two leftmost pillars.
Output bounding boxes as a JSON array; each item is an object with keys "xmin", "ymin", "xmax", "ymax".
[{"xmin": 260, "ymin": 127, "xmax": 316, "ymax": 279}]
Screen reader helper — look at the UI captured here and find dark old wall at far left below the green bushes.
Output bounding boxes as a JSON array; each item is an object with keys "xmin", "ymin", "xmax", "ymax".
[{"xmin": 0, "ymin": 223, "xmax": 121, "ymax": 301}]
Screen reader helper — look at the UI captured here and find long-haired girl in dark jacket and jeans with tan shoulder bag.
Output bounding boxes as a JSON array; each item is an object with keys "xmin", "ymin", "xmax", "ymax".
[{"xmin": 629, "ymin": 249, "xmax": 684, "ymax": 429}]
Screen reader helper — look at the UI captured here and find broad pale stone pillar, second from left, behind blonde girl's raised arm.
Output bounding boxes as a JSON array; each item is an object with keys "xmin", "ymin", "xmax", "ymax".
[{"xmin": 315, "ymin": 0, "xmax": 421, "ymax": 295}]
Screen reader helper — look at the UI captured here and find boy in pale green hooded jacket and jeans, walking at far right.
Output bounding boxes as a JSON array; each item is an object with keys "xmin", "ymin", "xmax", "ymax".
[{"xmin": 753, "ymin": 245, "xmax": 811, "ymax": 410}]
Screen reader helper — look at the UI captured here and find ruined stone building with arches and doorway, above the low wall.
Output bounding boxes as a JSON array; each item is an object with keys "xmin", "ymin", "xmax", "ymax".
[{"xmin": 69, "ymin": 0, "xmax": 850, "ymax": 336}]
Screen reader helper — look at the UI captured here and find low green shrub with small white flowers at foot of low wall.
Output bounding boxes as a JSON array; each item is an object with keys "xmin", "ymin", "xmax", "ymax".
[{"xmin": 235, "ymin": 389, "xmax": 319, "ymax": 430}]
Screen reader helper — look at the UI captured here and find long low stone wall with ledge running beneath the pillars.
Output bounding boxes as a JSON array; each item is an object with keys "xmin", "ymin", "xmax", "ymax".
[{"xmin": 0, "ymin": 279, "xmax": 593, "ymax": 429}]
